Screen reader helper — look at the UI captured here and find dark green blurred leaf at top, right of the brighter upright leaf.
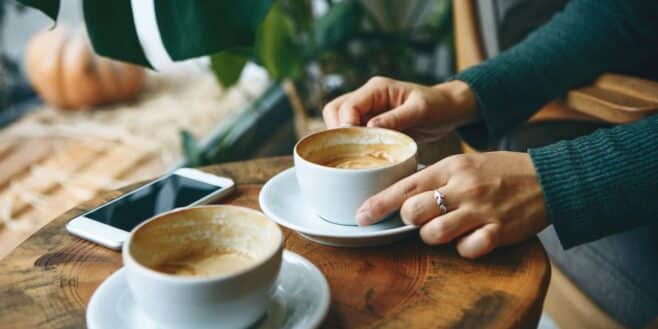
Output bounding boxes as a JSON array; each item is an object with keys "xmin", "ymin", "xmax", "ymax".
[{"xmin": 313, "ymin": 0, "xmax": 362, "ymax": 51}]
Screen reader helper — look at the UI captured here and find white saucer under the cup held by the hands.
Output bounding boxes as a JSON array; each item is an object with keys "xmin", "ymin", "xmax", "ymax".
[{"xmin": 258, "ymin": 168, "xmax": 417, "ymax": 247}]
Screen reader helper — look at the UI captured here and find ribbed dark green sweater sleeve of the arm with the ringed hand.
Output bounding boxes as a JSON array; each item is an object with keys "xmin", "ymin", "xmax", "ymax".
[{"xmin": 529, "ymin": 115, "xmax": 658, "ymax": 248}]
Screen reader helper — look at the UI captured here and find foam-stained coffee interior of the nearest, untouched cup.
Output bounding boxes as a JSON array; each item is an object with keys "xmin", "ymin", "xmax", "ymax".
[{"xmin": 130, "ymin": 205, "xmax": 283, "ymax": 277}]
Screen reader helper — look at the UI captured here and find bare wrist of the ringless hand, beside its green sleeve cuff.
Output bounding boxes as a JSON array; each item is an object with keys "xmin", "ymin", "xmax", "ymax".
[{"xmin": 434, "ymin": 80, "xmax": 479, "ymax": 126}]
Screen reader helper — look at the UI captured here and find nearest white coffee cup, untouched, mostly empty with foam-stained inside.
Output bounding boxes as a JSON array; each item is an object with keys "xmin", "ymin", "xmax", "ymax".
[{"xmin": 123, "ymin": 205, "xmax": 283, "ymax": 329}]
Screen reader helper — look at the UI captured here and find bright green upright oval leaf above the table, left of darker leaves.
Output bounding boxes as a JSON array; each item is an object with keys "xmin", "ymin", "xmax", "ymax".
[{"xmin": 256, "ymin": 4, "xmax": 303, "ymax": 79}]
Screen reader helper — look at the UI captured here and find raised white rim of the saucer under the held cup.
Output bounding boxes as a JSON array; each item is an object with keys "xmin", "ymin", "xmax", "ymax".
[{"xmin": 258, "ymin": 167, "xmax": 418, "ymax": 238}]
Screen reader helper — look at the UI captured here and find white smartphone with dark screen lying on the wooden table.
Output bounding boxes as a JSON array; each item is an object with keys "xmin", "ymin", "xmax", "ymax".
[{"xmin": 66, "ymin": 168, "xmax": 235, "ymax": 250}]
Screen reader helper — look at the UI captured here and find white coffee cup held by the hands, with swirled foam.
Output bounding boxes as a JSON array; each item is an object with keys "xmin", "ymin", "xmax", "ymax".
[{"xmin": 294, "ymin": 127, "xmax": 418, "ymax": 225}]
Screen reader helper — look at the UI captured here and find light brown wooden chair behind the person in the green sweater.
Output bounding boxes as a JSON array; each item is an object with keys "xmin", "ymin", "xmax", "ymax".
[{"xmin": 453, "ymin": 0, "xmax": 658, "ymax": 328}]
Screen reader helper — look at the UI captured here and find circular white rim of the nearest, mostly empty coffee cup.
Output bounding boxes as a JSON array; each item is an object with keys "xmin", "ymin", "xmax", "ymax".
[{"xmin": 121, "ymin": 205, "xmax": 285, "ymax": 283}]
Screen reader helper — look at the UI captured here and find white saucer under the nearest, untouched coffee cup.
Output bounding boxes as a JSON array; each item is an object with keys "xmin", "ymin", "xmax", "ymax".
[{"xmin": 87, "ymin": 251, "xmax": 330, "ymax": 329}]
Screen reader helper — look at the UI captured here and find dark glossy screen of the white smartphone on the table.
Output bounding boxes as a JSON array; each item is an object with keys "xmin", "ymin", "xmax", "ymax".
[{"xmin": 85, "ymin": 175, "xmax": 222, "ymax": 232}]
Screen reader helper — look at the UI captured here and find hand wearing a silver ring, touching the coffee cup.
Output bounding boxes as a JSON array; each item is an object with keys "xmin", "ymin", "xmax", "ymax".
[{"xmin": 357, "ymin": 152, "xmax": 548, "ymax": 258}]
